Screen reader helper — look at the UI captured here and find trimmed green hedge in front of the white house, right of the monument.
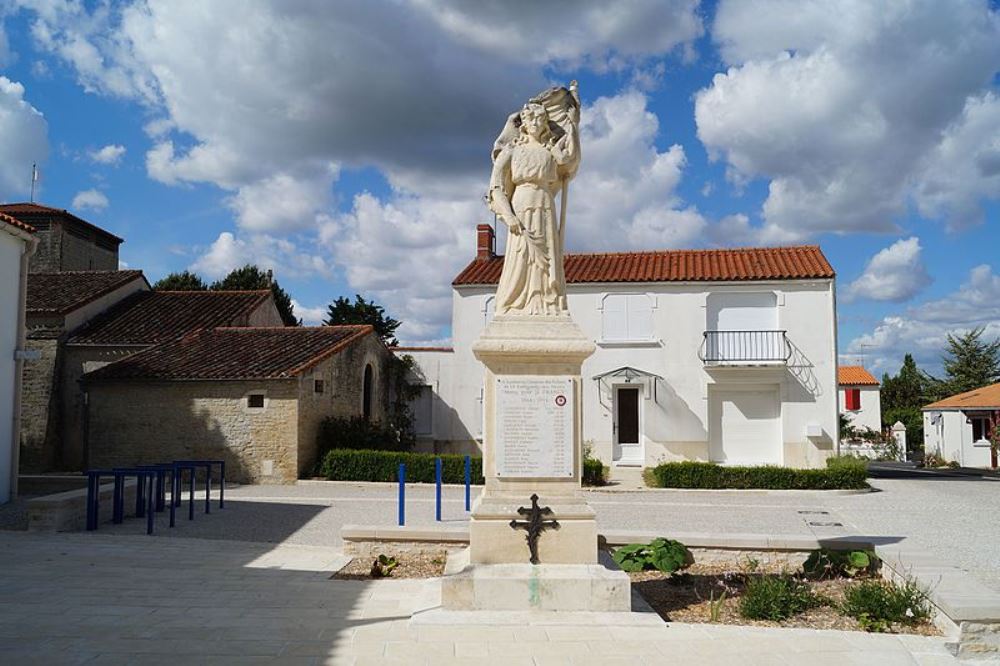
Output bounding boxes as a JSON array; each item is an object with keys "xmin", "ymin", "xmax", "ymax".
[{"xmin": 647, "ymin": 461, "xmax": 868, "ymax": 490}]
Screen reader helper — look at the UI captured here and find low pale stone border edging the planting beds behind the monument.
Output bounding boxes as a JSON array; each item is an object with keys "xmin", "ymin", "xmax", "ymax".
[{"xmin": 340, "ymin": 525, "xmax": 1000, "ymax": 660}]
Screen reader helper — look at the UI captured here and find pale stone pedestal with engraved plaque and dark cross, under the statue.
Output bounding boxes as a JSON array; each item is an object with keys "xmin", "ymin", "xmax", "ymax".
[{"xmin": 442, "ymin": 315, "xmax": 630, "ymax": 611}]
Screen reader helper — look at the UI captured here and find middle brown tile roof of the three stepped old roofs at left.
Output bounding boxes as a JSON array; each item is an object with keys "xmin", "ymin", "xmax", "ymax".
[{"xmin": 69, "ymin": 289, "xmax": 271, "ymax": 345}]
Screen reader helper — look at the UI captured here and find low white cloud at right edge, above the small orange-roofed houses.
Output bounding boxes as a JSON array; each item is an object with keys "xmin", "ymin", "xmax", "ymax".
[{"xmin": 847, "ymin": 264, "xmax": 1000, "ymax": 372}]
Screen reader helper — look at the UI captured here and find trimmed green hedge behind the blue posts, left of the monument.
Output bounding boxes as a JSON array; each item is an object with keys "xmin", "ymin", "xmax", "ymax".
[{"xmin": 320, "ymin": 449, "xmax": 483, "ymax": 484}]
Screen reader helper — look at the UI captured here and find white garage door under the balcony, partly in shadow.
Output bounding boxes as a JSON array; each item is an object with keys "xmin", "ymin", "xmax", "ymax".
[{"xmin": 709, "ymin": 386, "xmax": 783, "ymax": 465}]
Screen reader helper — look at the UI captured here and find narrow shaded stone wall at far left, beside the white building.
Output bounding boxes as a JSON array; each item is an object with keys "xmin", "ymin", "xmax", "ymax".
[{"xmin": 20, "ymin": 336, "xmax": 62, "ymax": 473}]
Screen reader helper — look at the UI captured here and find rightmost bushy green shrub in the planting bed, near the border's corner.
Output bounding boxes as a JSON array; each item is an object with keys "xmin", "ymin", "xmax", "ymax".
[{"xmin": 842, "ymin": 579, "xmax": 930, "ymax": 631}]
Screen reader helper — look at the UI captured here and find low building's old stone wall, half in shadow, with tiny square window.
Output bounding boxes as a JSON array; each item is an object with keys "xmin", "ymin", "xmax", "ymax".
[{"xmin": 87, "ymin": 380, "xmax": 299, "ymax": 483}]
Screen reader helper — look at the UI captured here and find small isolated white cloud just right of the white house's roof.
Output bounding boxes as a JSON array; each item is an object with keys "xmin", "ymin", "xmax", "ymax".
[{"xmin": 844, "ymin": 236, "xmax": 932, "ymax": 302}]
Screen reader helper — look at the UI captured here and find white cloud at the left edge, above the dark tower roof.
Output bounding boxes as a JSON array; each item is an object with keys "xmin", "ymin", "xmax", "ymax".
[{"xmin": 0, "ymin": 76, "xmax": 48, "ymax": 201}]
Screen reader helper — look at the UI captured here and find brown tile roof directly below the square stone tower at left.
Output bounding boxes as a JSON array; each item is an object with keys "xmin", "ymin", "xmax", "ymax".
[{"xmin": 26, "ymin": 271, "xmax": 149, "ymax": 315}]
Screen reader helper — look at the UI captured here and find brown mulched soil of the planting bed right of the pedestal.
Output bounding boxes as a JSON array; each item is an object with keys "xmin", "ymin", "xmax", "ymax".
[{"xmin": 629, "ymin": 562, "xmax": 941, "ymax": 636}]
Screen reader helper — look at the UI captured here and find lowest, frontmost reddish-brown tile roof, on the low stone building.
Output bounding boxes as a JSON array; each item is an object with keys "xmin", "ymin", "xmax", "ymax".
[{"xmin": 84, "ymin": 326, "xmax": 374, "ymax": 381}]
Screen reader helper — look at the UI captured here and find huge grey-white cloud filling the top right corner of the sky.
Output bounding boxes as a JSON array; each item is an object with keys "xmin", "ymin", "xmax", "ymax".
[{"xmin": 695, "ymin": 0, "xmax": 1000, "ymax": 240}]
